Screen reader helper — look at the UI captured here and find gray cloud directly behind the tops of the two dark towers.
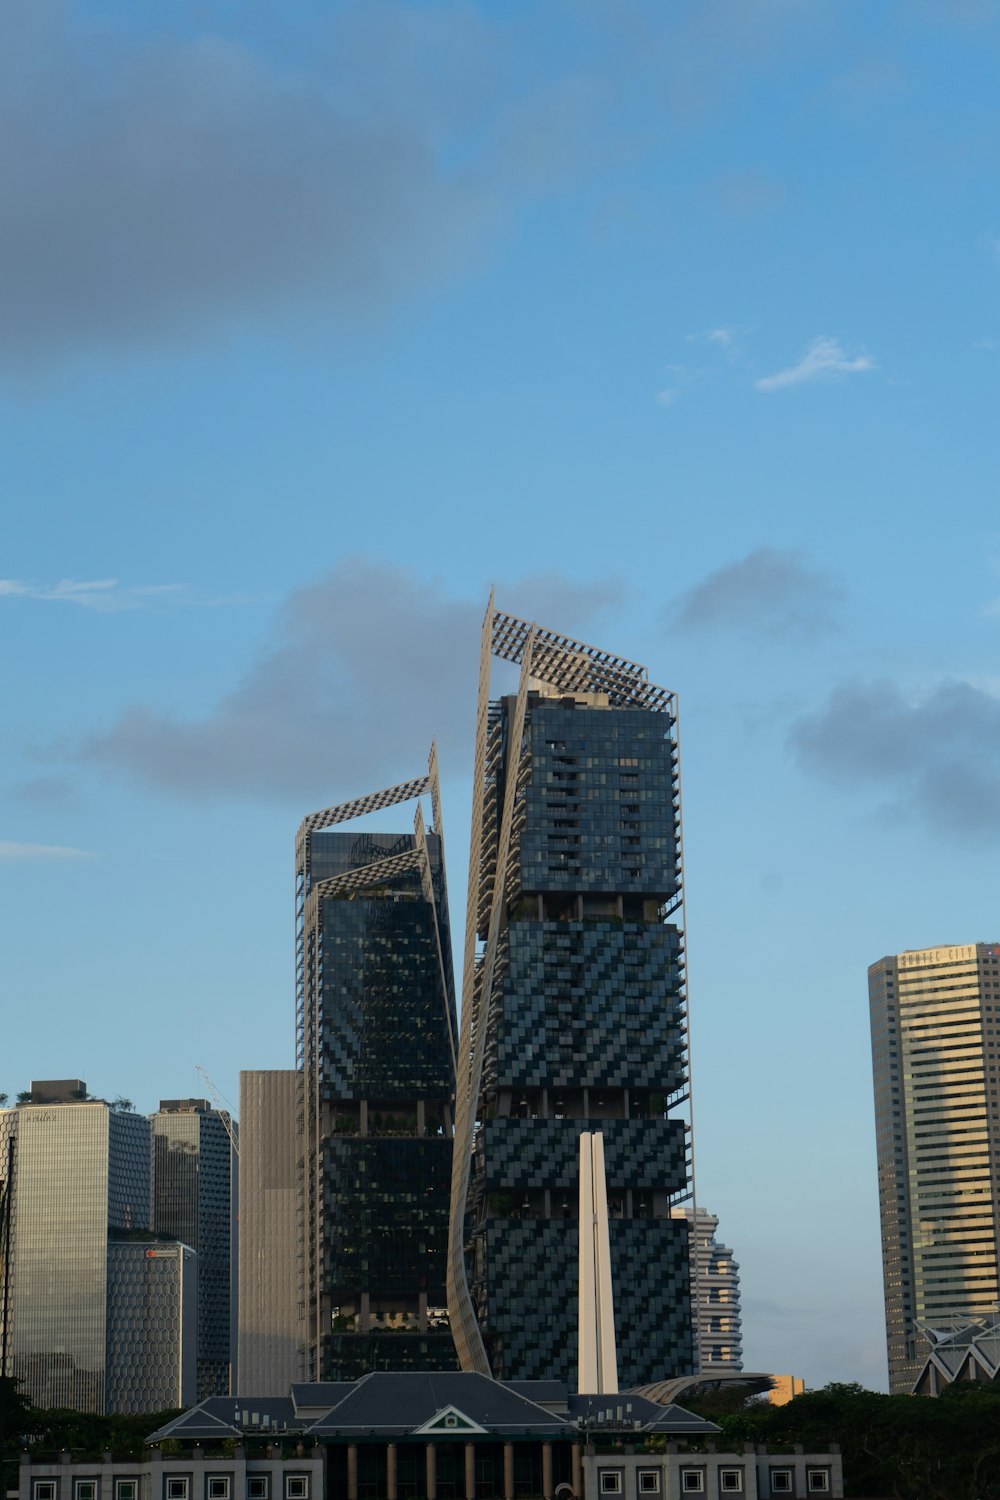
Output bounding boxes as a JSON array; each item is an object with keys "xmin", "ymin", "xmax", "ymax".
[{"xmin": 78, "ymin": 560, "xmax": 616, "ymax": 801}]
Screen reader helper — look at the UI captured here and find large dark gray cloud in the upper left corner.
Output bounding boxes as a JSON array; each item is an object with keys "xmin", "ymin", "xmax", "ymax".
[{"xmin": 0, "ymin": 9, "xmax": 500, "ymax": 366}]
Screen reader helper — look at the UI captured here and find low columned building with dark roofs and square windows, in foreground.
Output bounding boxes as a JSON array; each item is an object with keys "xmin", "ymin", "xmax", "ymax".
[{"xmin": 18, "ymin": 1373, "xmax": 844, "ymax": 1500}]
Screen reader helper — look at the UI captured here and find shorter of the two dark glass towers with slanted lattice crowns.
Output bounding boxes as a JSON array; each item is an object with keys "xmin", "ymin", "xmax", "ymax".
[{"xmin": 297, "ymin": 750, "xmax": 456, "ymax": 1380}]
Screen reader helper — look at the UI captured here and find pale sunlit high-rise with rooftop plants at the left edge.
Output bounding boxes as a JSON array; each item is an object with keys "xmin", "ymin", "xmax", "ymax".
[{"xmin": 0, "ymin": 1079, "xmax": 160, "ymax": 1413}]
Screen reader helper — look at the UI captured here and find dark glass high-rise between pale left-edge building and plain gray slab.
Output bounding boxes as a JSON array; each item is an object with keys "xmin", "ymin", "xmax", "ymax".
[{"xmin": 150, "ymin": 1100, "xmax": 237, "ymax": 1401}]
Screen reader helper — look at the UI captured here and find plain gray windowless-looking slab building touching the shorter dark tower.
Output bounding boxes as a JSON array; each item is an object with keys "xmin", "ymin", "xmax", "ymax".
[{"xmin": 235, "ymin": 1068, "xmax": 304, "ymax": 1397}]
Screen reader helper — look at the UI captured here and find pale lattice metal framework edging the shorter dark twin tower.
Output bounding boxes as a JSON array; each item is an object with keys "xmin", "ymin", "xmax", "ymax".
[{"xmin": 295, "ymin": 744, "xmax": 456, "ymax": 1379}]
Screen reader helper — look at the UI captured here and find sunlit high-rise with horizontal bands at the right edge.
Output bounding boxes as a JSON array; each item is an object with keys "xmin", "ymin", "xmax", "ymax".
[{"xmin": 868, "ymin": 944, "xmax": 1000, "ymax": 1392}]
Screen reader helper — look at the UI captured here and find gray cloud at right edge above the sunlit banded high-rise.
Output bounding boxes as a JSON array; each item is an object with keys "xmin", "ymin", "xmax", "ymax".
[{"xmin": 789, "ymin": 680, "xmax": 1000, "ymax": 839}]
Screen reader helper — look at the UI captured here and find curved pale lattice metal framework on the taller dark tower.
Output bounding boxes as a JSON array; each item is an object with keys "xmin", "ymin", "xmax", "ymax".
[{"xmin": 448, "ymin": 593, "xmax": 694, "ymax": 1376}]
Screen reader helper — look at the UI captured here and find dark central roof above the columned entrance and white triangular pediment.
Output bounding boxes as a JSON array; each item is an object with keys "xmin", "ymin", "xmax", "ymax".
[{"xmin": 306, "ymin": 1371, "xmax": 565, "ymax": 1437}]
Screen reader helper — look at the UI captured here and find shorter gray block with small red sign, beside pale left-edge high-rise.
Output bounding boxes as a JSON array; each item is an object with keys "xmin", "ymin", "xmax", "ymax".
[{"xmin": 105, "ymin": 1238, "xmax": 198, "ymax": 1413}]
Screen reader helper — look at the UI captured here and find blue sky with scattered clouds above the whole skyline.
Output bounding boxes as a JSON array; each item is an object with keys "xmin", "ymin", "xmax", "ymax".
[{"xmin": 0, "ymin": 0, "xmax": 1000, "ymax": 1385}]
